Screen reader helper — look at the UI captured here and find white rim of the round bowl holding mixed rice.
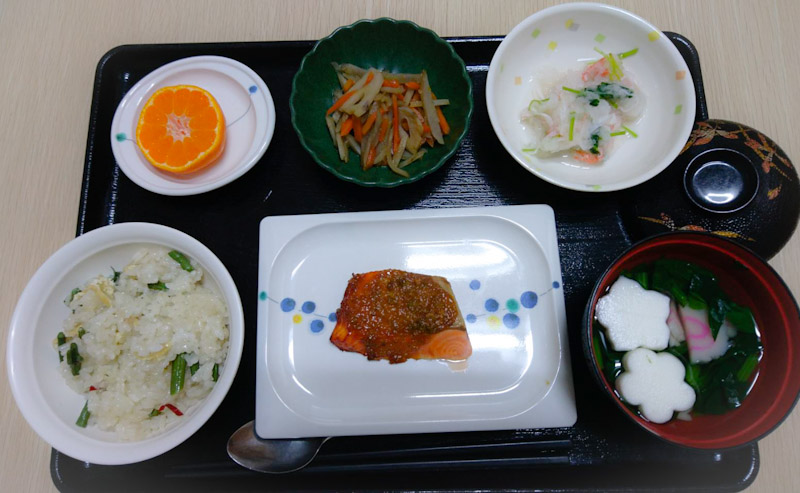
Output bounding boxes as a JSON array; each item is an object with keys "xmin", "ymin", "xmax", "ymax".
[{"xmin": 6, "ymin": 223, "xmax": 244, "ymax": 465}]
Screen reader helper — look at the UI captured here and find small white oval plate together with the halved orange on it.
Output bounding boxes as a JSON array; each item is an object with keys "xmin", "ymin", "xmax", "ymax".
[{"xmin": 111, "ymin": 56, "xmax": 275, "ymax": 195}]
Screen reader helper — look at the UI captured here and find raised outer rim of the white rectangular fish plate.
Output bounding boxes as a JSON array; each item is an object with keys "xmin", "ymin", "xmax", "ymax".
[{"xmin": 256, "ymin": 205, "xmax": 577, "ymax": 438}]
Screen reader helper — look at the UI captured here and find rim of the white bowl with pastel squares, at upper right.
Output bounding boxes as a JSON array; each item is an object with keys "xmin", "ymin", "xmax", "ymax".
[{"xmin": 485, "ymin": 2, "xmax": 696, "ymax": 192}]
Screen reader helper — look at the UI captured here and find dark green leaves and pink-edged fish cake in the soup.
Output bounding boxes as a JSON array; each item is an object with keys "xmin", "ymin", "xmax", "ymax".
[{"xmin": 593, "ymin": 258, "xmax": 763, "ymax": 414}]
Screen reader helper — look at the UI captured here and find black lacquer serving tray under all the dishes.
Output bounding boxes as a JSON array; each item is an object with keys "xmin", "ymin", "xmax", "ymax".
[{"xmin": 51, "ymin": 33, "xmax": 764, "ymax": 492}]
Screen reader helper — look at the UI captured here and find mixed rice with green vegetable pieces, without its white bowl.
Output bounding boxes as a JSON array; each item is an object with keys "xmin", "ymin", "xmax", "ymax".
[{"xmin": 58, "ymin": 246, "xmax": 228, "ymax": 440}]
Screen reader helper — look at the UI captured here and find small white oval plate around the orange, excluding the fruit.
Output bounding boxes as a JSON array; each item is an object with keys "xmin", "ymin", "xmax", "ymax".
[{"xmin": 110, "ymin": 55, "xmax": 276, "ymax": 195}]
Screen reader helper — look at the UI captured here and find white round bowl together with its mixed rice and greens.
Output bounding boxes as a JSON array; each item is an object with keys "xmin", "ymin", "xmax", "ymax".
[{"xmin": 7, "ymin": 223, "xmax": 244, "ymax": 464}]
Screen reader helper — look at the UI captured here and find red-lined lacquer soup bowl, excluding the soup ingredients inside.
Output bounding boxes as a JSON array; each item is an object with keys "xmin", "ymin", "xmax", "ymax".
[{"xmin": 582, "ymin": 232, "xmax": 800, "ymax": 449}]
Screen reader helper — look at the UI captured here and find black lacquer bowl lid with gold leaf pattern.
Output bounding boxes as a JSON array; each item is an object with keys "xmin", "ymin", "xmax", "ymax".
[{"xmin": 623, "ymin": 120, "xmax": 800, "ymax": 259}]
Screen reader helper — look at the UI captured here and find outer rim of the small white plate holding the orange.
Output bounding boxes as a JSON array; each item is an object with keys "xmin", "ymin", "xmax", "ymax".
[{"xmin": 110, "ymin": 55, "xmax": 276, "ymax": 196}]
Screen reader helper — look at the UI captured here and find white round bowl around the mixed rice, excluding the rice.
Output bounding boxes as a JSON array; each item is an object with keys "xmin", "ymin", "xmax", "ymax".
[{"xmin": 6, "ymin": 223, "xmax": 244, "ymax": 464}]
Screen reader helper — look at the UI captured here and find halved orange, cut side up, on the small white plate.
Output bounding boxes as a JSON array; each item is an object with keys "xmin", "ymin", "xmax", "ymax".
[{"xmin": 136, "ymin": 86, "xmax": 225, "ymax": 174}]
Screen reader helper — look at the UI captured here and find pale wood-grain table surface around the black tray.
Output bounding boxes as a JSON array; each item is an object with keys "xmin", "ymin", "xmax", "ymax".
[{"xmin": 0, "ymin": 0, "xmax": 800, "ymax": 492}]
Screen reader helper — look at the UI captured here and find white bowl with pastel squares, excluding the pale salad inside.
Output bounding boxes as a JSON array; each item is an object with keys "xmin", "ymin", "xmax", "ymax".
[{"xmin": 486, "ymin": 3, "xmax": 695, "ymax": 192}]
